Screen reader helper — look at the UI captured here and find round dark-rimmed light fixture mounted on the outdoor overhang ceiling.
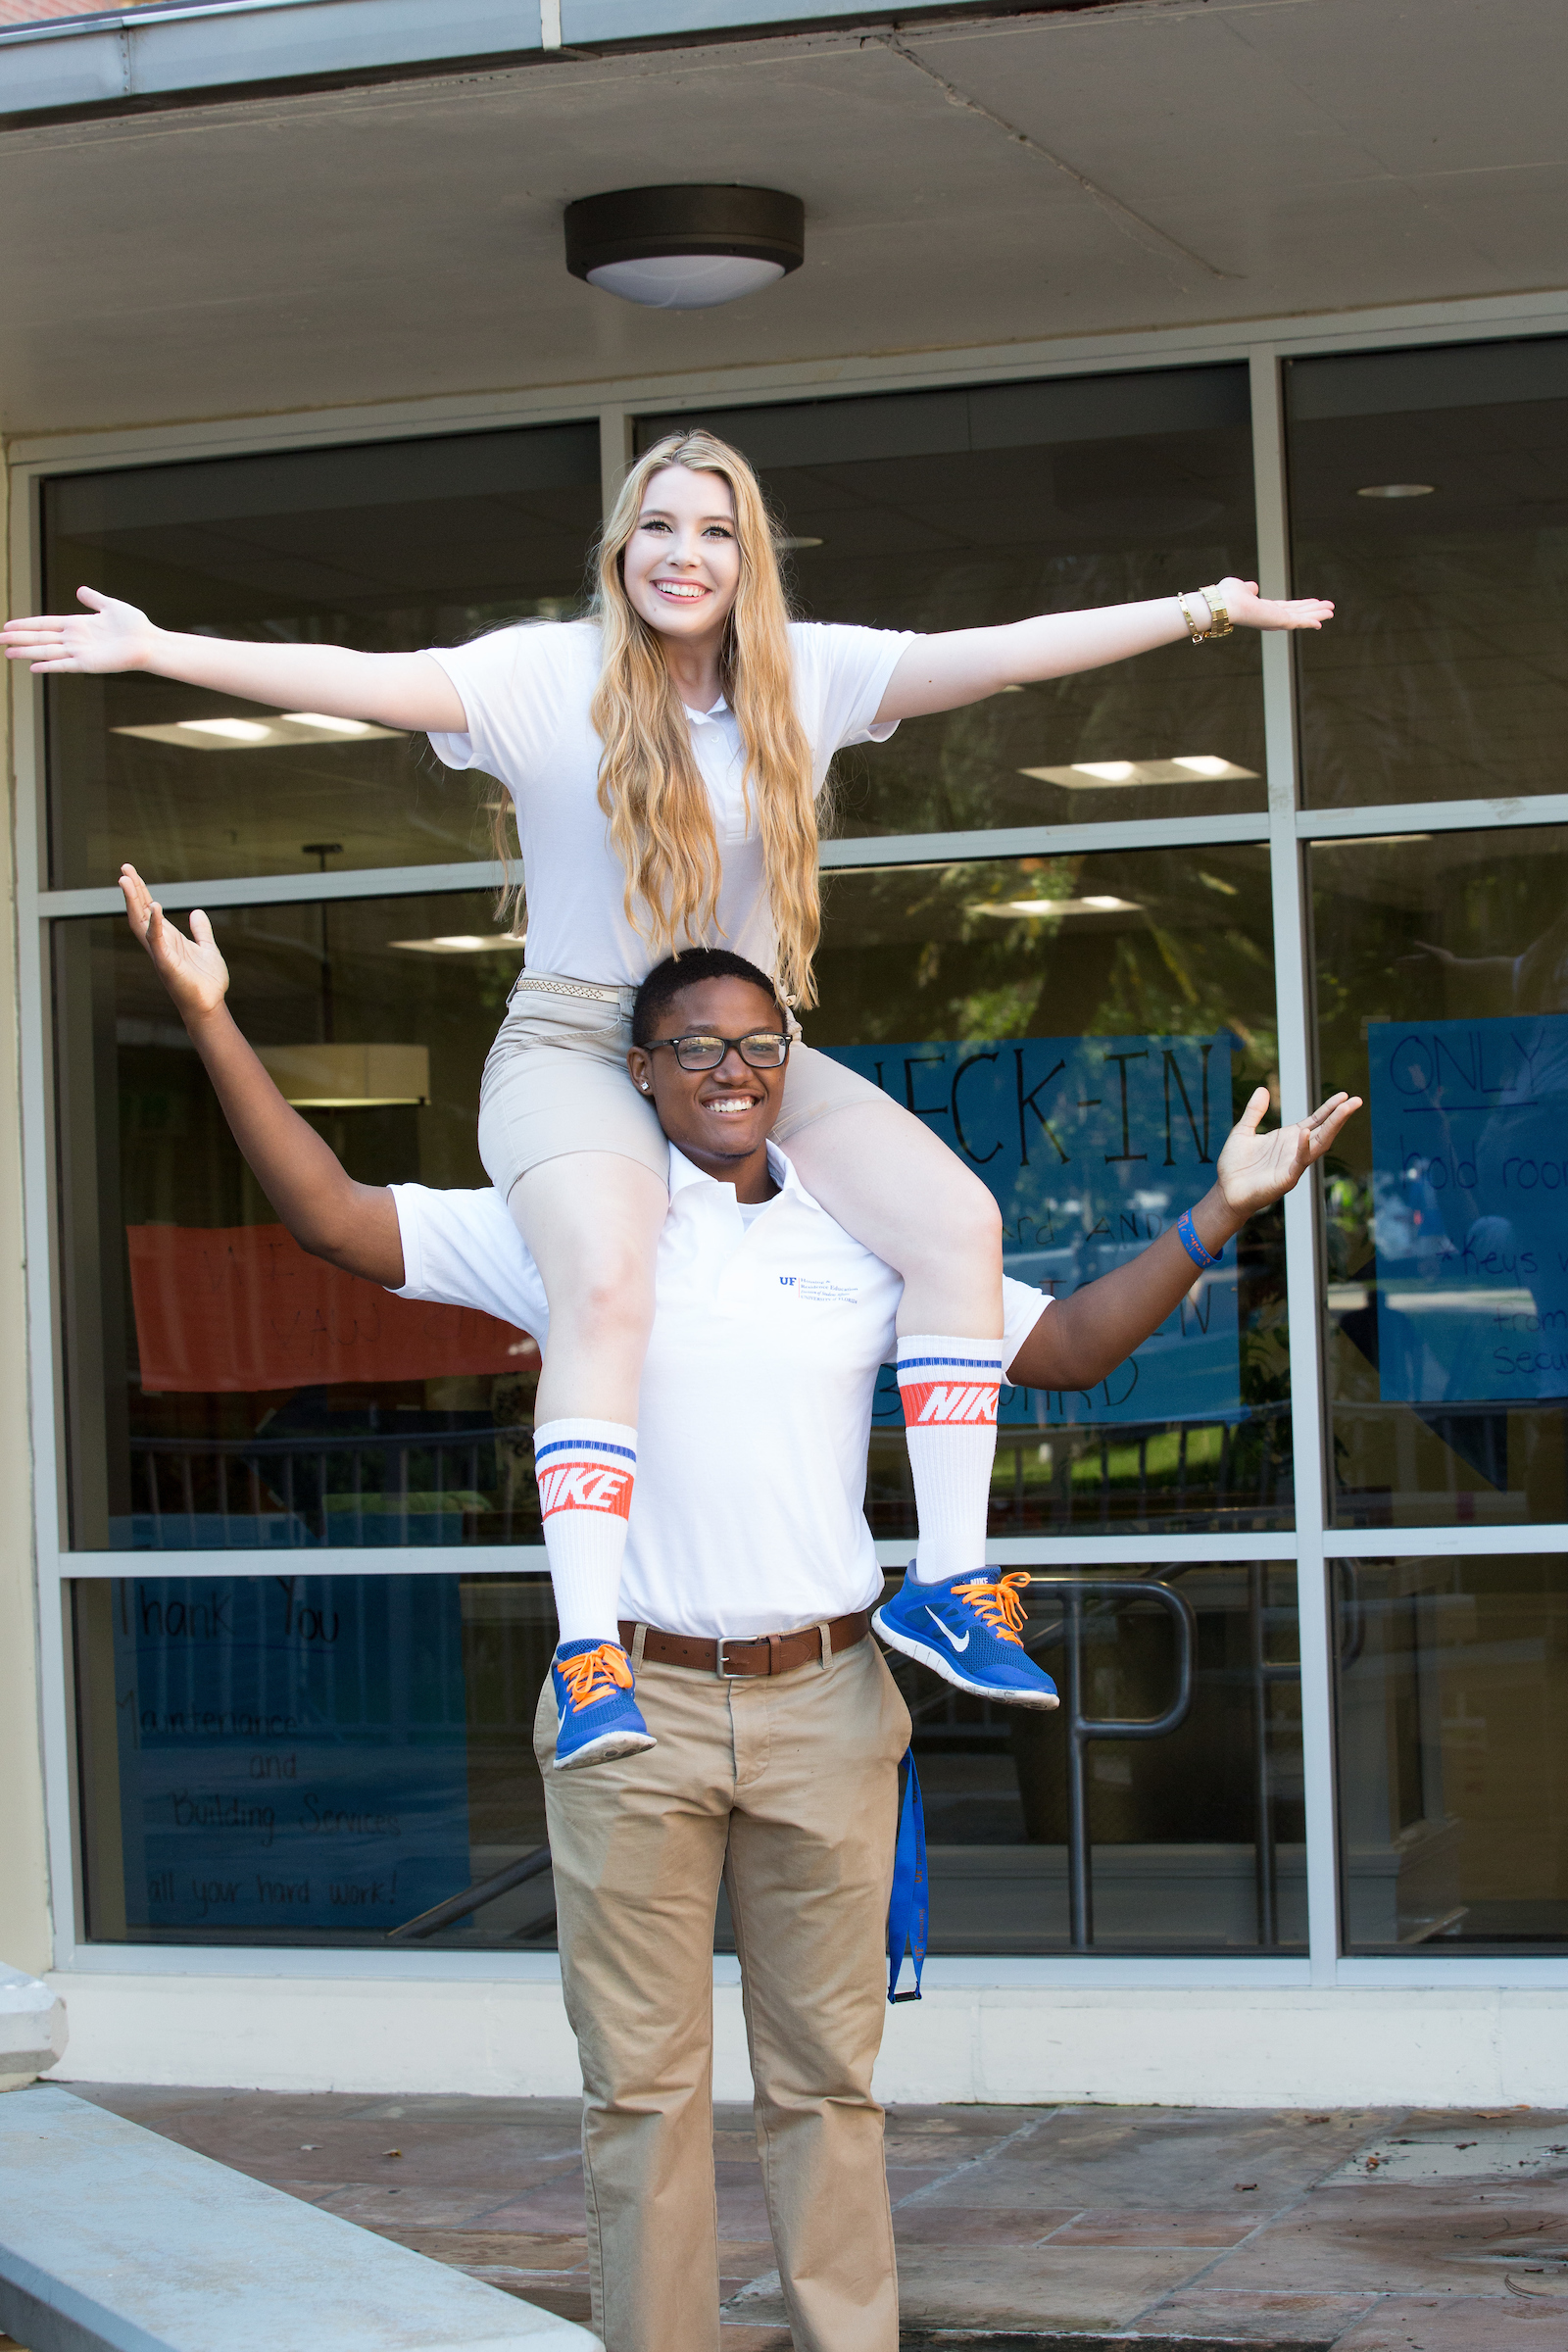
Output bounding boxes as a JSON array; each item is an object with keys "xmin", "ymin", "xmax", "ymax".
[{"xmin": 564, "ymin": 186, "xmax": 807, "ymax": 311}]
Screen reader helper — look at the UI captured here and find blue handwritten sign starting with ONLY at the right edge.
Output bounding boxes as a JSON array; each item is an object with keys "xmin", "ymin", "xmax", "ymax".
[{"xmin": 1366, "ymin": 1013, "xmax": 1568, "ymax": 1404}]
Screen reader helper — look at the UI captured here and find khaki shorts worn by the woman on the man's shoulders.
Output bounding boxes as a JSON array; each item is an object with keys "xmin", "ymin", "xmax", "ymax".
[{"xmin": 479, "ymin": 971, "xmax": 884, "ymax": 1200}]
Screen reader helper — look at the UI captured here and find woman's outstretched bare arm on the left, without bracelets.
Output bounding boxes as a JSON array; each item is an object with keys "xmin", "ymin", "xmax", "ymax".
[{"xmin": 0, "ymin": 588, "xmax": 467, "ymax": 734}]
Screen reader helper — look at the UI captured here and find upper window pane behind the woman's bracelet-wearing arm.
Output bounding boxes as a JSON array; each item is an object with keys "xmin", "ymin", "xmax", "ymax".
[{"xmin": 639, "ymin": 367, "xmax": 1265, "ymax": 835}]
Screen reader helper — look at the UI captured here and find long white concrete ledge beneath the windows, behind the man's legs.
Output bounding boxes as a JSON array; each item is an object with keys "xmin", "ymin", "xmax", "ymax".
[{"xmin": 36, "ymin": 1964, "xmax": 1568, "ymax": 2107}]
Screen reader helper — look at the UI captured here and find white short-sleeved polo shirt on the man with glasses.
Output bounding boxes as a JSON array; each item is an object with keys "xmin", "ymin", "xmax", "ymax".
[{"xmin": 390, "ymin": 1143, "xmax": 1051, "ymax": 1637}]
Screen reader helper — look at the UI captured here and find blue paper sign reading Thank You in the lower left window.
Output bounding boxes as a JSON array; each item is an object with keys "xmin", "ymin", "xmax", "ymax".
[{"xmin": 116, "ymin": 1576, "xmax": 470, "ymax": 1934}]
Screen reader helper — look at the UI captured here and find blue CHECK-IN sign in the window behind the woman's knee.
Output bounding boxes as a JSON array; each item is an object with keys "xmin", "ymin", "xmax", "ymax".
[{"xmin": 832, "ymin": 1030, "xmax": 1244, "ymax": 1428}]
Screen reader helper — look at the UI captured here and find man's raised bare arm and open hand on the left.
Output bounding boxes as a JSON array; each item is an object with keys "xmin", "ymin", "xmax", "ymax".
[{"xmin": 120, "ymin": 865, "xmax": 405, "ymax": 1292}]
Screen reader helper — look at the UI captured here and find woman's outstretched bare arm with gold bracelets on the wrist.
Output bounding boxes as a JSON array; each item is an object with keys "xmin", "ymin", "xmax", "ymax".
[{"xmin": 877, "ymin": 578, "xmax": 1333, "ymax": 722}]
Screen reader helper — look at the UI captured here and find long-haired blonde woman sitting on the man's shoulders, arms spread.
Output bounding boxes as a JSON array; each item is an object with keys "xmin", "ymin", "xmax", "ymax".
[{"xmin": 5, "ymin": 433, "xmax": 1333, "ymax": 1766}]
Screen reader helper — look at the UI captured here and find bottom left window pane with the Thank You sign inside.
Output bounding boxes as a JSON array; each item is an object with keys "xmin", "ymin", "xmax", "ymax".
[{"xmin": 71, "ymin": 1564, "xmax": 555, "ymax": 1952}]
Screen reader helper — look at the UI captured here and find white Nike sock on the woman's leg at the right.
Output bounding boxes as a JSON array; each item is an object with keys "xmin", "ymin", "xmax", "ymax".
[{"xmin": 898, "ymin": 1331, "xmax": 1002, "ymax": 1586}]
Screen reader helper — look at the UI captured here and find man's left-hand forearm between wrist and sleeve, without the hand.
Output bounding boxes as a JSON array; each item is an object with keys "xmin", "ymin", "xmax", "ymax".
[{"xmin": 186, "ymin": 1004, "xmax": 405, "ymax": 1289}]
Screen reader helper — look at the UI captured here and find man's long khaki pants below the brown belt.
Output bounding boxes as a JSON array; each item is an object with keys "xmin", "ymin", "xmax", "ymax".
[{"xmin": 534, "ymin": 1640, "xmax": 909, "ymax": 2352}]
